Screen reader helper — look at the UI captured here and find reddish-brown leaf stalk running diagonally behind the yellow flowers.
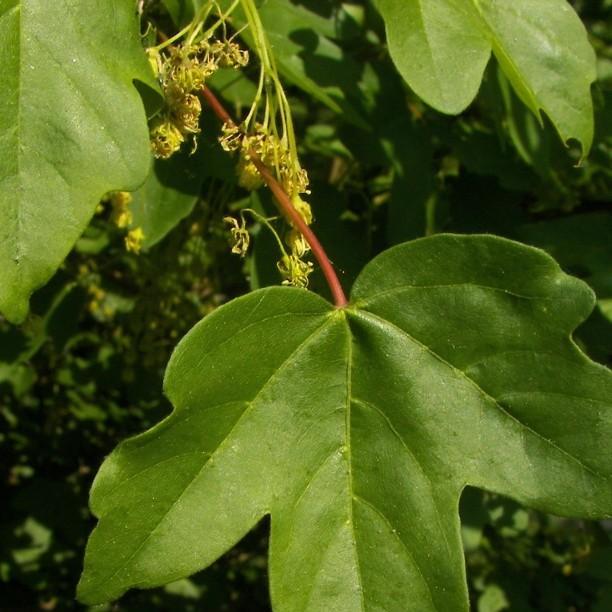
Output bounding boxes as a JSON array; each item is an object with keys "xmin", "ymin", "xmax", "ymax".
[{"xmin": 201, "ymin": 87, "xmax": 348, "ymax": 308}]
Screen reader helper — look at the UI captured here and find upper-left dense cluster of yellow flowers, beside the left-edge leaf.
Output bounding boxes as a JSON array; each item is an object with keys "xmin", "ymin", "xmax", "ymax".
[{"xmin": 149, "ymin": 40, "xmax": 249, "ymax": 159}]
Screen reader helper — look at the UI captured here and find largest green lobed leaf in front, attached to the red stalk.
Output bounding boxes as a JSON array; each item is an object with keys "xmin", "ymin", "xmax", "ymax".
[{"xmin": 79, "ymin": 235, "xmax": 612, "ymax": 612}]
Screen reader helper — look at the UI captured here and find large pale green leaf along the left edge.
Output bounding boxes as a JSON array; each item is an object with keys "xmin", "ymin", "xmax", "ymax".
[{"xmin": 0, "ymin": 0, "xmax": 157, "ymax": 322}]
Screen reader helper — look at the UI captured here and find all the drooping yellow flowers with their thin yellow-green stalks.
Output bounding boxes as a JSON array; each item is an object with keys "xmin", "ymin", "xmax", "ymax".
[{"xmin": 143, "ymin": 0, "xmax": 313, "ymax": 287}]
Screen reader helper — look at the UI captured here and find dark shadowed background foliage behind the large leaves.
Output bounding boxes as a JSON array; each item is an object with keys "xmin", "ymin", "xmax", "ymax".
[{"xmin": 0, "ymin": 0, "xmax": 612, "ymax": 612}]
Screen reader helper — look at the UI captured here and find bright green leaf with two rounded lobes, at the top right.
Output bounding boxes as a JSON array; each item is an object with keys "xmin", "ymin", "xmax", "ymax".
[{"xmin": 376, "ymin": 0, "xmax": 596, "ymax": 155}]
